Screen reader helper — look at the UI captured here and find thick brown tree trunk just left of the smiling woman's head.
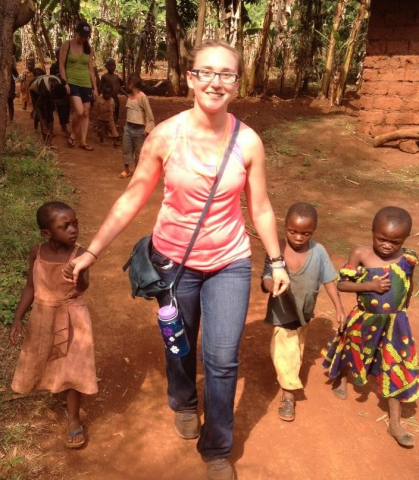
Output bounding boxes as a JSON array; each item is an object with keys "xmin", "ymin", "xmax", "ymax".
[{"xmin": 166, "ymin": 0, "xmax": 188, "ymax": 96}]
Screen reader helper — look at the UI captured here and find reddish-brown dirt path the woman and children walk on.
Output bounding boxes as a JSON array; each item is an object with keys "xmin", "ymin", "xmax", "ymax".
[{"xmin": 12, "ymin": 98, "xmax": 419, "ymax": 480}]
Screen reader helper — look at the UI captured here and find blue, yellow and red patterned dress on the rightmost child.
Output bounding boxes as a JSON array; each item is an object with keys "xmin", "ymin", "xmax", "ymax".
[{"xmin": 322, "ymin": 249, "xmax": 419, "ymax": 402}]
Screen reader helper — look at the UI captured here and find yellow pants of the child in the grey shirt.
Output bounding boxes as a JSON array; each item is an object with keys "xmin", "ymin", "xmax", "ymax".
[{"xmin": 271, "ymin": 325, "xmax": 308, "ymax": 390}]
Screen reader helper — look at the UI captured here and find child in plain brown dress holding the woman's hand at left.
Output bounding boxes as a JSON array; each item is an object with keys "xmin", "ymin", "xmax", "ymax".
[{"xmin": 9, "ymin": 202, "xmax": 97, "ymax": 448}]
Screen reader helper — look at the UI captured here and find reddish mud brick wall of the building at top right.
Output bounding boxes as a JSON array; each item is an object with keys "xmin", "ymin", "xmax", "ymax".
[{"xmin": 358, "ymin": 0, "xmax": 419, "ymax": 137}]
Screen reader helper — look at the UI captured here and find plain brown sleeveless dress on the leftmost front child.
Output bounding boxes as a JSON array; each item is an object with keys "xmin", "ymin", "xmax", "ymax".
[{"xmin": 12, "ymin": 245, "xmax": 97, "ymax": 394}]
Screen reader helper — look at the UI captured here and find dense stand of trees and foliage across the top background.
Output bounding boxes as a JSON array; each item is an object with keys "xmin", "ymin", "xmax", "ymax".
[{"xmin": 16, "ymin": 0, "xmax": 370, "ymax": 95}]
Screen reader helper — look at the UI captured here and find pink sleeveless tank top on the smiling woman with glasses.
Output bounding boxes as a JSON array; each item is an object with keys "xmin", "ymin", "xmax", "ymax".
[{"xmin": 153, "ymin": 111, "xmax": 251, "ymax": 272}]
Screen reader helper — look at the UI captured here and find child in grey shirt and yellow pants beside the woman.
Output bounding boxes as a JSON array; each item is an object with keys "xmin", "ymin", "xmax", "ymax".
[{"xmin": 262, "ymin": 202, "xmax": 345, "ymax": 422}]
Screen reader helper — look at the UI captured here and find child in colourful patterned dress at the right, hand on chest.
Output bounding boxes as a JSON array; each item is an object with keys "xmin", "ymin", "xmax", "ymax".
[{"xmin": 322, "ymin": 207, "xmax": 419, "ymax": 447}]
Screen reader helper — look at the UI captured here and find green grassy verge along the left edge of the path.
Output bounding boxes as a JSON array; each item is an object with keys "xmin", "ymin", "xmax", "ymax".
[{"xmin": 0, "ymin": 127, "xmax": 75, "ymax": 480}]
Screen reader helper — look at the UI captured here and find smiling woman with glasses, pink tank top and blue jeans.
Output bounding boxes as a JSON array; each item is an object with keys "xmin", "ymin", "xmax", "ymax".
[{"xmin": 65, "ymin": 40, "xmax": 289, "ymax": 480}]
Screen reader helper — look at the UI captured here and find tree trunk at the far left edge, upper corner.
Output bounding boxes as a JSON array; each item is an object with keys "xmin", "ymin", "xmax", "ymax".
[{"xmin": 0, "ymin": 0, "xmax": 35, "ymax": 173}]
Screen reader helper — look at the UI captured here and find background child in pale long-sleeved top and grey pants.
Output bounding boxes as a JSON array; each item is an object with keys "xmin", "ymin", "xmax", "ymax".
[{"xmin": 119, "ymin": 73, "xmax": 155, "ymax": 178}]
